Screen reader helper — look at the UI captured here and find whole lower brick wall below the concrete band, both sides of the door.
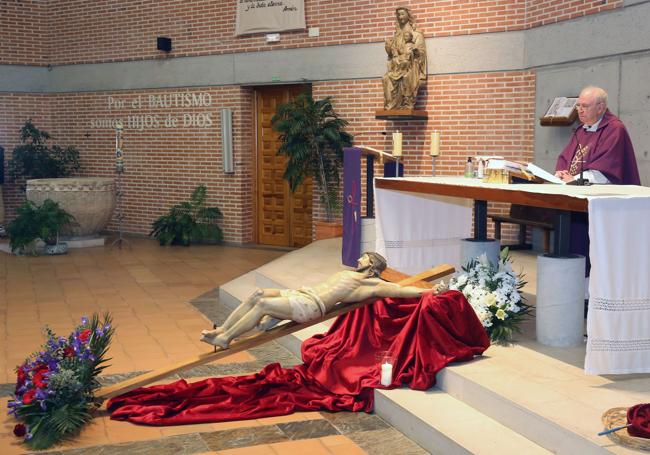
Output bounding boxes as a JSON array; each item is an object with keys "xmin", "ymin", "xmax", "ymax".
[{"xmin": 0, "ymin": 72, "xmax": 535, "ymax": 242}]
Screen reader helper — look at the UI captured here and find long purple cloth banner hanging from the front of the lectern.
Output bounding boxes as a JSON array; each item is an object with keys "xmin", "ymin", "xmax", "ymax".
[{"xmin": 341, "ymin": 147, "xmax": 362, "ymax": 267}]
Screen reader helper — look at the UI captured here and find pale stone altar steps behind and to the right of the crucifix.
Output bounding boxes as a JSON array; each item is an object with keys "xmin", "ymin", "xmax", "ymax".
[{"xmin": 219, "ymin": 241, "xmax": 650, "ymax": 454}]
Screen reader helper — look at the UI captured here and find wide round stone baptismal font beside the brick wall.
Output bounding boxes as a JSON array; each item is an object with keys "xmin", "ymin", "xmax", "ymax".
[{"xmin": 27, "ymin": 177, "xmax": 115, "ymax": 238}]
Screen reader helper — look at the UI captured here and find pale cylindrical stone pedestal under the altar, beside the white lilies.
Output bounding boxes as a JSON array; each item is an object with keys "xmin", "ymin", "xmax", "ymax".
[{"xmin": 535, "ymin": 255, "xmax": 585, "ymax": 347}]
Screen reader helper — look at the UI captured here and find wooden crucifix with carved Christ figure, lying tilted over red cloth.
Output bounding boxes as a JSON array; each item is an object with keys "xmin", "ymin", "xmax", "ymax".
[{"xmin": 95, "ymin": 253, "xmax": 454, "ymax": 399}]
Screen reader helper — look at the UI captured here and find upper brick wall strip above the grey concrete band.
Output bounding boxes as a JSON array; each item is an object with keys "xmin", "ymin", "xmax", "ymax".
[{"xmin": 0, "ymin": 0, "xmax": 623, "ymax": 65}]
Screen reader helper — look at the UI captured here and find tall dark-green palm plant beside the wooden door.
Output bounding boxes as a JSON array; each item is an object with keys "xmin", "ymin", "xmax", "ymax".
[{"xmin": 271, "ymin": 93, "xmax": 352, "ymax": 238}]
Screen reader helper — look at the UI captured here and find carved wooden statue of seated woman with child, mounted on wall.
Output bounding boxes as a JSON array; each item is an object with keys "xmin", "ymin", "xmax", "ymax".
[{"xmin": 382, "ymin": 7, "xmax": 427, "ymax": 109}]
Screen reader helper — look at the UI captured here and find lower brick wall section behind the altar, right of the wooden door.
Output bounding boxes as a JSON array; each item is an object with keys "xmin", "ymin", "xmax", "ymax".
[{"xmin": 313, "ymin": 71, "xmax": 535, "ymax": 238}]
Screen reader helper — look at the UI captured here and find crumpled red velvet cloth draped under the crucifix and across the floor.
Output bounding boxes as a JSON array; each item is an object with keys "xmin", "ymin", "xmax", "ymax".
[{"xmin": 107, "ymin": 291, "xmax": 489, "ymax": 425}]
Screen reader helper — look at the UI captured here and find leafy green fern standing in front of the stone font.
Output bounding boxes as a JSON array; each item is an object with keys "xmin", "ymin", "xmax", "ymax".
[{"xmin": 8, "ymin": 199, "xmax": 74, "ymax": 255}]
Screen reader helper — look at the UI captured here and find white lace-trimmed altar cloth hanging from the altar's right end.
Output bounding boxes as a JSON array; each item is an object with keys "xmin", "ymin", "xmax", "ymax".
[{"xmin": 585, "ymin": 197, "xmax": 650, "ymax": 374}]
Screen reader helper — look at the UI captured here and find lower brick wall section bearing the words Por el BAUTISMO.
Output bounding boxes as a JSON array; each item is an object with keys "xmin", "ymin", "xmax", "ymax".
[{"xmin": 0, "ymin": 87, "xmax": 253, "ymax": 242}]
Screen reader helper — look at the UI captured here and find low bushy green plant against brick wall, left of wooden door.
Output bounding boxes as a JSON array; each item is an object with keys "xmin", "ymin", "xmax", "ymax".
[{"xmin": 149, "ymin": 185, "xmax": 223, "ymax": 246}]
